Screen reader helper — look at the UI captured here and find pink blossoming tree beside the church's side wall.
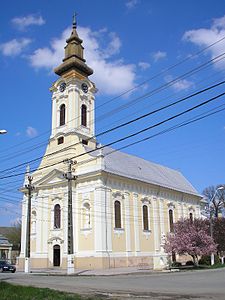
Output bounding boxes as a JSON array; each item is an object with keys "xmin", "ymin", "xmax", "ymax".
[{"xmin": 164, "ymin": 219, "xmax": 216, "ymax": 265}]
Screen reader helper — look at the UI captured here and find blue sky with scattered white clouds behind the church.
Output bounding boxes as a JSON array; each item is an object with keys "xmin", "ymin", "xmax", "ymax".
[{"xmin": 0, "ymin": 0, "xmax": 225, "ymax": 226}]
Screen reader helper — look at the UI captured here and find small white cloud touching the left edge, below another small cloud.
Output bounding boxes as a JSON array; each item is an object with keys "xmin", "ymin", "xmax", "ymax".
[{"xmin": 0, "ymin": 38, "xmax": 31, "ymax": 56}]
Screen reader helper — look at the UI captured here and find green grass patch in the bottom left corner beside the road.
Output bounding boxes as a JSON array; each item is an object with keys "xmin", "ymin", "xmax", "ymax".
[{"xmin": 0, "ymin": 281, "xmax": 100, "ymax": 300}]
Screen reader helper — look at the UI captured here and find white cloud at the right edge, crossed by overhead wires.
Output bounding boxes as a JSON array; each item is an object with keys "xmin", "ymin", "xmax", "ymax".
[{"xmin": 183, "ymin": 16, "xmax": 225, "ymax": 69}]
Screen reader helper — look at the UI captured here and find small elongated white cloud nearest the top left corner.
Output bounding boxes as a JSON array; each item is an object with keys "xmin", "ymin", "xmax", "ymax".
[{"xmin": 11, "ymin": 15, "xmax": 45, "ymax": 30}]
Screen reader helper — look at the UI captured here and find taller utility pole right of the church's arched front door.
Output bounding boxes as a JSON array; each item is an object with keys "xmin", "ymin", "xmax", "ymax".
[{"xmin": 64, "ymin": 159, "xmax": 76, "ymax": 274}]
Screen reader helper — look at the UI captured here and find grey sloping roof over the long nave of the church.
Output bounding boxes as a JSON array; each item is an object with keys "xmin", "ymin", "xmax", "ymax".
[{"xmin": 86, "ymin": 147, "xmax": 201, "ymax": 197}]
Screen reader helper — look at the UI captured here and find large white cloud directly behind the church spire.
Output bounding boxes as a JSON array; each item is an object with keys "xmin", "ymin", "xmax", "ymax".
[{"xmin": 30, "ymin": 27, "xmax": 136, "ymax": 95}]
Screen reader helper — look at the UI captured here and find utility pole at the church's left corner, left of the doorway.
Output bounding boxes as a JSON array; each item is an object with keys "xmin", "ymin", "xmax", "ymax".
[{"xmin": 24, "ymin": 176, "xmax": 34, "ymax": 273}]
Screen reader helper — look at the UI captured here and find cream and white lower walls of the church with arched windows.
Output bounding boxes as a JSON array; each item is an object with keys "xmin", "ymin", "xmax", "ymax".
[{"xmin": 20, "ymin": 172, "xmax": 200, "ymax": 268}]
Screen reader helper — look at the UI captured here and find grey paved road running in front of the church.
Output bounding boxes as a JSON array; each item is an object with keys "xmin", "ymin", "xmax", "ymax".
[{"xmin": 0, "ymin": 269, "xmax": 225, "ymax": 300}]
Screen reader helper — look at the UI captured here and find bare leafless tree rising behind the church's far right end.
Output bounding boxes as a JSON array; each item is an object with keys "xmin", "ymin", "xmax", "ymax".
[{"xmin": 202, "ymin": 184, "xmax": 225, "ymax": 218}]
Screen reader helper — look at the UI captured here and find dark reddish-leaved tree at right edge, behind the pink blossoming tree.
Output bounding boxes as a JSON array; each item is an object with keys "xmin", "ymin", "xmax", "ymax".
[{"xmin": 213, "ymin": 218, "xmax": 225, "ymax": 256}]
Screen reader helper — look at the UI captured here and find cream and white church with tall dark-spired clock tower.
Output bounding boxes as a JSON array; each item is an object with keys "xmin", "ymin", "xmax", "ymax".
[{"xmin": 18, "ymin": 20, "xmax": 201, "ymax": 273}]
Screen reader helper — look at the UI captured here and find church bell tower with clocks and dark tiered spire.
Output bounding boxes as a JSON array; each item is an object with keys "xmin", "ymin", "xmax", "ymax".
[{"xmin": 50, "ymin": 15, "xmax": 97, "ymax": 144}]
